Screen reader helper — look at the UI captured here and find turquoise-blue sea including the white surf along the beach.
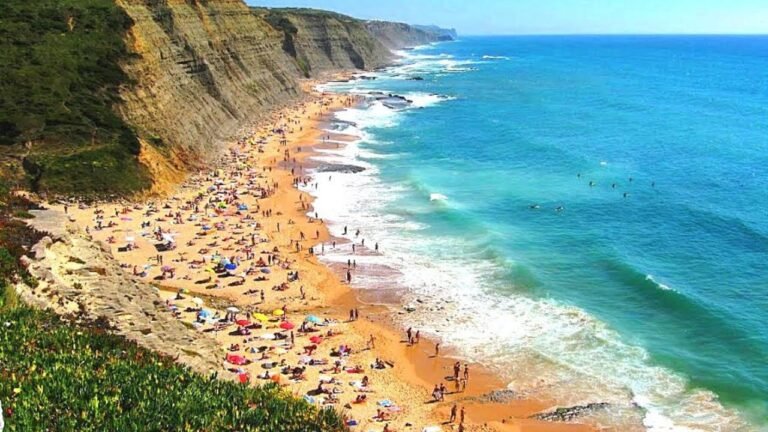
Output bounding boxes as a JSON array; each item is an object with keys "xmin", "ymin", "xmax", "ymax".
[{"xmin": 316, "ymin": 36, "xmax": 768, "ymax": 431}]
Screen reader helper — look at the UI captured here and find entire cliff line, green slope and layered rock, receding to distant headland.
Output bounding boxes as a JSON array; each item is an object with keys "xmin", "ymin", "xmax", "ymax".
[{"xmin": 0, "ymin": 0, "xmax": 452, "ymax": 194}]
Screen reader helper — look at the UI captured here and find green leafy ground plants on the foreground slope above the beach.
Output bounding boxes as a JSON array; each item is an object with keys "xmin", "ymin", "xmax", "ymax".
[{"xmin": 0, "ymin": 307, "xmax": 344, "ymax": 432}]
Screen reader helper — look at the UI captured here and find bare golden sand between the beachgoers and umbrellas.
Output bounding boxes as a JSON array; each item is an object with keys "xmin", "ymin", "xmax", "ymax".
[{"xmin": 51, "ymin": 84, "xmax": 592, "ymax": 431}]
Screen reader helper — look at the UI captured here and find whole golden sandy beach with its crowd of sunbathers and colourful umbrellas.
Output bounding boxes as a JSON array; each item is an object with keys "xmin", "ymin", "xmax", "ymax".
[{"xmin": 50, "ymin": 83, "xmax": 592, "ymax": 431}]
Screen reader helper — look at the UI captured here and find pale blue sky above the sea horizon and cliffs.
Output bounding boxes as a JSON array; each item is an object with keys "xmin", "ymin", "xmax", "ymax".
[{"xmin": 246, "ymin": 0, "xmax": 768, "ymax": 35}]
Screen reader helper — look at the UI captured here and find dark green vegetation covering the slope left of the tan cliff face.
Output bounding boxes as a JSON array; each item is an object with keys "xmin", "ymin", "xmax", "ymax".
[{"xmin": 0, "ymin": 0, "xmax": 148, "ymax": 194}]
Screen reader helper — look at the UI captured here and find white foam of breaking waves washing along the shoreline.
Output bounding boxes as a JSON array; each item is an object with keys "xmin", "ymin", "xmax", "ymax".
[{"xmin": 308, "ymin": 49, "xmax": 749, "ymax": 432}]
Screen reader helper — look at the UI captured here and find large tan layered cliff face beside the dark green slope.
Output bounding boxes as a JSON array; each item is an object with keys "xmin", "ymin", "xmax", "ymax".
[{"xmin": 117, "ymin": 0, "xmax": 300, "ymax": 174}]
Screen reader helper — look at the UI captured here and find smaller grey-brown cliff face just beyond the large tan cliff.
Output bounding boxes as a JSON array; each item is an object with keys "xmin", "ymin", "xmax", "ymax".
[{"xmin": 254, "ymin": 8, "xmax": 393, "ymax": 77}]
